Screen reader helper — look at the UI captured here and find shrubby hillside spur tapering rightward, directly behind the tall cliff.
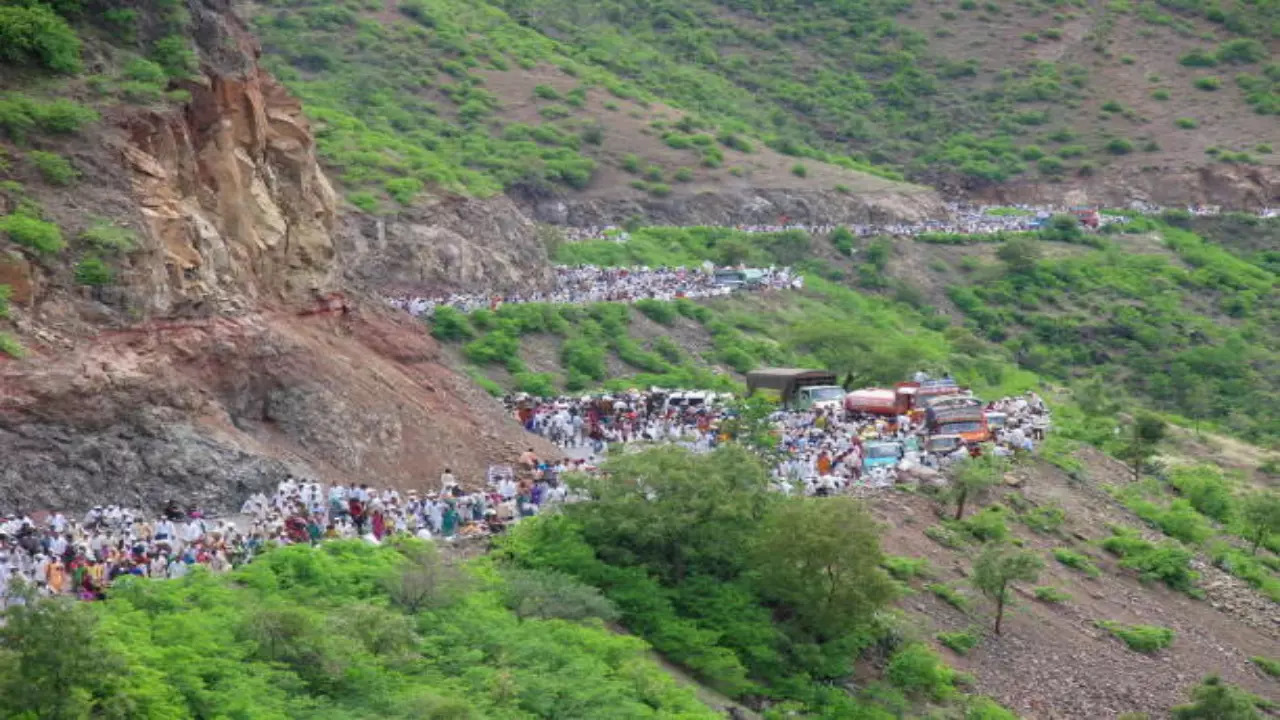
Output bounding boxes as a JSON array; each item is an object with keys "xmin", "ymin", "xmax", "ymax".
[{"xmin": 246, "ymin": 0, "xmax": 938, "ymax": 225}]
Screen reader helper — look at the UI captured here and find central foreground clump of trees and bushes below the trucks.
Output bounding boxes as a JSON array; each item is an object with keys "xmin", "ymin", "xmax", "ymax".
[{"xmin": 499, "ymin": 446, "xmax": 998, "ymax": 717}]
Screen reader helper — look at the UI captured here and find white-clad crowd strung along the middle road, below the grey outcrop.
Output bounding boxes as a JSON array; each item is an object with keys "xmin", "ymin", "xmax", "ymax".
[{"xmin": 387, "ymin": 265, "xmax": 804, "ymax": 318}]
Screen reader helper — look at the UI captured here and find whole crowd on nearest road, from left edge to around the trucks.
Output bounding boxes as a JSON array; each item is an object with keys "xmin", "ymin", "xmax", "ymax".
[{"xmin": 0, "ymin": 376, "xmax": 1048, "ymax": 607}]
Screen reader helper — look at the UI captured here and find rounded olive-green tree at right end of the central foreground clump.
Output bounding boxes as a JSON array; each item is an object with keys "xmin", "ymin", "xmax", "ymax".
[{"xmin": 751, "ymin": 497, "xmax": 896, "ymax": 642}]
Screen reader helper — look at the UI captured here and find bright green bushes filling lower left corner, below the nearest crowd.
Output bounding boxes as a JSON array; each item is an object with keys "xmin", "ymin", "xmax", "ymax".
[{"xmin": 0, "ymin": 541, "xmax": 716, "ymax": 720}]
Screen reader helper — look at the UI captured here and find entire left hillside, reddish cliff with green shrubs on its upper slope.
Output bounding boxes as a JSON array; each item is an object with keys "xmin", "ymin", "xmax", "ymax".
[{"xmin": 0, "ymin": 0, "xmax": 555, "ymax": 509}]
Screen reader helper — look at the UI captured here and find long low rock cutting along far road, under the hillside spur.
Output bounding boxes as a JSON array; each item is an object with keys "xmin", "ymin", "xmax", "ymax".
[{"xmin": 521, "ymin": 188, "xmax": 945, "ymax": 227}]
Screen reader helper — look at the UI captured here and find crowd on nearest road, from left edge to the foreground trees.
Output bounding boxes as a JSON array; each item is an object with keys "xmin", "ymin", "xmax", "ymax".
[{"xmin": 0, "ymin": 450, "xmax": 593, "ymax": 609}]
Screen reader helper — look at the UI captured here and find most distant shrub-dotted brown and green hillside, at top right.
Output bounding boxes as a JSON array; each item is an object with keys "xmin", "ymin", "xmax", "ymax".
[{"xmin": 486, "ymin": 0, "xmax": 1280, "ymax": 205}]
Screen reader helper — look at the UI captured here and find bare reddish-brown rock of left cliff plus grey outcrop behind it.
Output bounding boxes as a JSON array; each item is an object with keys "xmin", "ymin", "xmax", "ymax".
[{"xmin": 0, "ymin": 0, "xmax": 552, "ymax": 510}]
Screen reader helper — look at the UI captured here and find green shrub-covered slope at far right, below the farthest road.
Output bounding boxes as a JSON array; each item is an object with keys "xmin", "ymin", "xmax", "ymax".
[{"xmin": 948, "ymin": 218, "xmax": 1280, "ymax": 440}]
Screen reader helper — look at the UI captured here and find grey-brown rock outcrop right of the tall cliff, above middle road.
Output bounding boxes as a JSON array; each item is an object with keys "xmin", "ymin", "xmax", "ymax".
[{"xmin": 337, "ymin": 196, "xmax": 550, "ymax": 292}]
